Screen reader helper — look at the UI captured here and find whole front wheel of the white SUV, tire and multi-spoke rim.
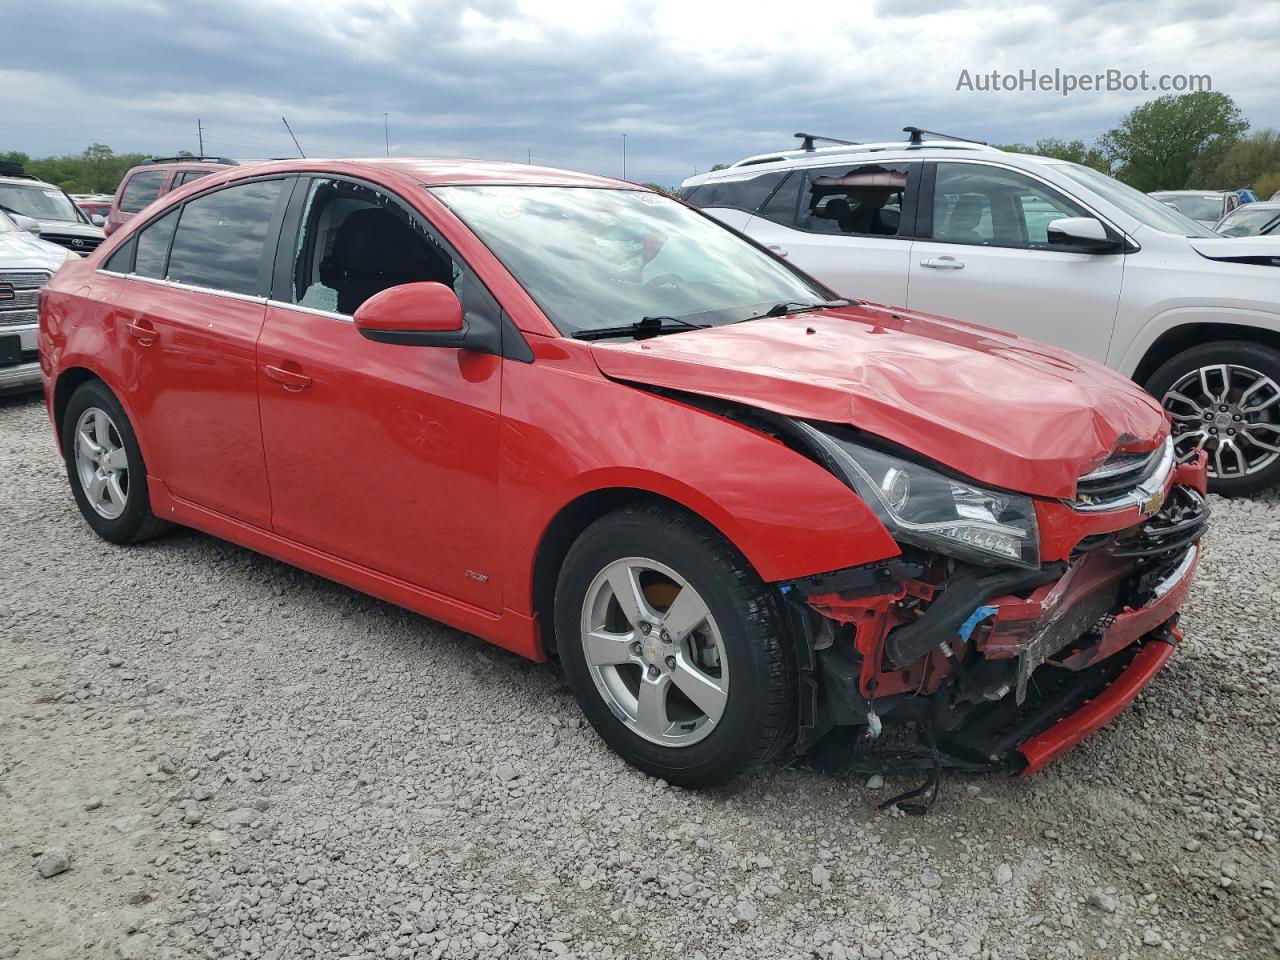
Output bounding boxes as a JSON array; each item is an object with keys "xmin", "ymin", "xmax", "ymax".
[{"xmin": 1146, "ymin": 340, "xmax": 1280, "ymax": 497}]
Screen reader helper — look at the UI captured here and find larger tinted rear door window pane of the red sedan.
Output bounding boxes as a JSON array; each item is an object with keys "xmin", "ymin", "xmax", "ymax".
[{"xmin": 168, "ymin": 179, "xmax": 287, "ymax": 294}]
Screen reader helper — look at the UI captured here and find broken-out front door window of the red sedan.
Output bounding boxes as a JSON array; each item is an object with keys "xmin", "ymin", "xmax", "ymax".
[{"xmin": 289, "ymin": 179, "xmax": 465, "ymax": 316}]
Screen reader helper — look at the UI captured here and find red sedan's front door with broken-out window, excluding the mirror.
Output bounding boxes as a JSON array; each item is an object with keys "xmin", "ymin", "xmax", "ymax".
[{"xmin": 259, "ymin": 178, "xmax": 503, "ymax": 612}]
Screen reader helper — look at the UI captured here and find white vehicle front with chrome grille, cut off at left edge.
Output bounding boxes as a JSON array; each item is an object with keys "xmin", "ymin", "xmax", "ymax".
[{"xmin": 0, "ymin": 211, "xmax": 79, "ymax": 396}]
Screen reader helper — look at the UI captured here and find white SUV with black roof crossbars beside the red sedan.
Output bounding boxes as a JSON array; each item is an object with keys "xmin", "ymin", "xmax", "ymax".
[{"xmin": 681, "ymin": 127, "xmax": 1280, "ymax": 494}]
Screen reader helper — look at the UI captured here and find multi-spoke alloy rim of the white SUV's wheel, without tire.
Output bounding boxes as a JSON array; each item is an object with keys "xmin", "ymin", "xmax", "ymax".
[{"xmin": 1162, "ymin": 364, "xmax": 1280, "ymax": 480}]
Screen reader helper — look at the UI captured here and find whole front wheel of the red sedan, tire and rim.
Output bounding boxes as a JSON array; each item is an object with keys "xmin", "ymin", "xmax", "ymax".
[{"xmin": 556, "ymin": 506, "xmax": 795, "ymax": 786}]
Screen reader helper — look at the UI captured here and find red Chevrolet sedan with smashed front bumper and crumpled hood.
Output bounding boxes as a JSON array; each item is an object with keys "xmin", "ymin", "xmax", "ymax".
[{"xmin": 40, "ymin": 160, "xmax": 1208, "ymax": 785}]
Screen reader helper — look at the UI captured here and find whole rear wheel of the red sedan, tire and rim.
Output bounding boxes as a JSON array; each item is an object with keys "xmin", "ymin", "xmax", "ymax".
[{"xmin": 61, "ymin": 380, "xmax": 169, "ymax": 544}]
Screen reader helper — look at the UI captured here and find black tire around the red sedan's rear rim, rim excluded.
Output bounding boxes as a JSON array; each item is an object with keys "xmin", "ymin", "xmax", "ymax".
[{"xmin": 61, "ymin": 380, "xmax": 172, "ymax": 544}]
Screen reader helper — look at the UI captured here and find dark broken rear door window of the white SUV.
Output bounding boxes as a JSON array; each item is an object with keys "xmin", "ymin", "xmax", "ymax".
[{"xmin": 796, "ymin": 164, "xmax": 910, "ymax": 237}]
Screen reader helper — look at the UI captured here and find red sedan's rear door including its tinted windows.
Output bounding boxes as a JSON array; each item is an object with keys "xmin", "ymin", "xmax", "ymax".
[{"xmin": 106, "ymin": 178, "xmax": 293, "ymax": 529}]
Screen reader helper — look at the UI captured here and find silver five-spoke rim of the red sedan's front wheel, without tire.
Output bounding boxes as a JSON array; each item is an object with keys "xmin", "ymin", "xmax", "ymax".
[{"xmin": 581, "ymin": 557, "xmax": 728, "ymax": 748}]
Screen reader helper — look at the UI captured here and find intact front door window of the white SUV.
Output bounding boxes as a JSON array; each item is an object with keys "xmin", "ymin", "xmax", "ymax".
[{"xmin": 933, "ymin": 163, "xmax": 1092, "ymax": 248}]
